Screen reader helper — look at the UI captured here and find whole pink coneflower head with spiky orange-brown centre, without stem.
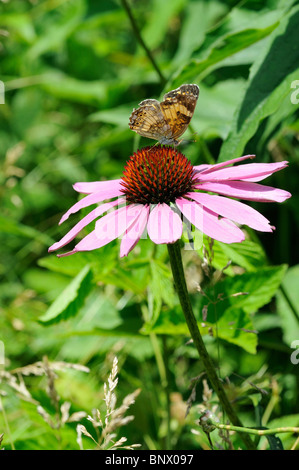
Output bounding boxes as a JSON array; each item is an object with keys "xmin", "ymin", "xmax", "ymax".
[{"xmin": 49, "ymin": 145, "xmax": 291, "ymax": 257}]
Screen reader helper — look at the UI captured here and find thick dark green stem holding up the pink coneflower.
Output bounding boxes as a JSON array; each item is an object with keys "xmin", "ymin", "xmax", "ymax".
[{"xmin": 167, "ymin": 240, "xmax": 256, "ymax": 450}]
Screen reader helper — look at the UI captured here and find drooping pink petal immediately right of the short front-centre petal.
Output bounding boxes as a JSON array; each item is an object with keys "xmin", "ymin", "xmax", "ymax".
[{"xmin": 176, "ymin": 198, "xmax": 245, "ymax": 243}]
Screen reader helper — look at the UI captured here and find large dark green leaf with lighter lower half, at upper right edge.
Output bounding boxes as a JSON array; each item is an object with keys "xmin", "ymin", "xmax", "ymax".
[{"xmin": 219, "ymin": 7, "xmax": 299, "ymax": 161}]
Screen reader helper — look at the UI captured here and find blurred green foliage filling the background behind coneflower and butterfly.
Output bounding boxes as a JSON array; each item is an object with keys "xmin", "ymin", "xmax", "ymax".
[{"xmin": 0, "ymin": 0, "xmax": 299, "ymax": 449}]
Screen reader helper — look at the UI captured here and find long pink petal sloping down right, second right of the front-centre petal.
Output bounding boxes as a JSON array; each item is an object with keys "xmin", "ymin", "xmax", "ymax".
[{"xmin": 185, "ymin": 193, "xmax": 272, "ymax": 232}]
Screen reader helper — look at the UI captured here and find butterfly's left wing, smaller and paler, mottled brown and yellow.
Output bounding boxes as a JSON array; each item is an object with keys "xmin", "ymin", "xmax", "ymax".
[{"xmin": 129, "ymin": 99, "xmax": 171, "ymax": 140}]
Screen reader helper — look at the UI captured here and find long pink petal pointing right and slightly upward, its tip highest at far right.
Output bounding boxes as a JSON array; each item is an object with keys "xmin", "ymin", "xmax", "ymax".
[{"xmin": 197, "ymin": 161, "xmax": 288, "ymax": 182}]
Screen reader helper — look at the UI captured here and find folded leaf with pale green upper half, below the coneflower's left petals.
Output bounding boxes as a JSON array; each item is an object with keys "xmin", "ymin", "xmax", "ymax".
[{"xmin": 39, "ymin": 266, "xmax": 93, "ymax": 325}]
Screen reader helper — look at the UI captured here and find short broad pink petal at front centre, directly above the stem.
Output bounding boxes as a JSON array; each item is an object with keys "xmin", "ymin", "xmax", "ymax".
[{"xmin": 147, "ymin": 203, "xmax": 183, "ymax": 245}]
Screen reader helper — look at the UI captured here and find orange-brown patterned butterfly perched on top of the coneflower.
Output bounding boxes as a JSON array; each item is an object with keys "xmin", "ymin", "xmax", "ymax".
[{"xmin": 129, "ymin": 85, "xmax": 199, "ymax": 145}]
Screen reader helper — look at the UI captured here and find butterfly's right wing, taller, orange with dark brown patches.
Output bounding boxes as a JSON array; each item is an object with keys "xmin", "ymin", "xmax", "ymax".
[{"xmin": 160, "ymin": 85, "xmax": 199, "ymax": 140}]
